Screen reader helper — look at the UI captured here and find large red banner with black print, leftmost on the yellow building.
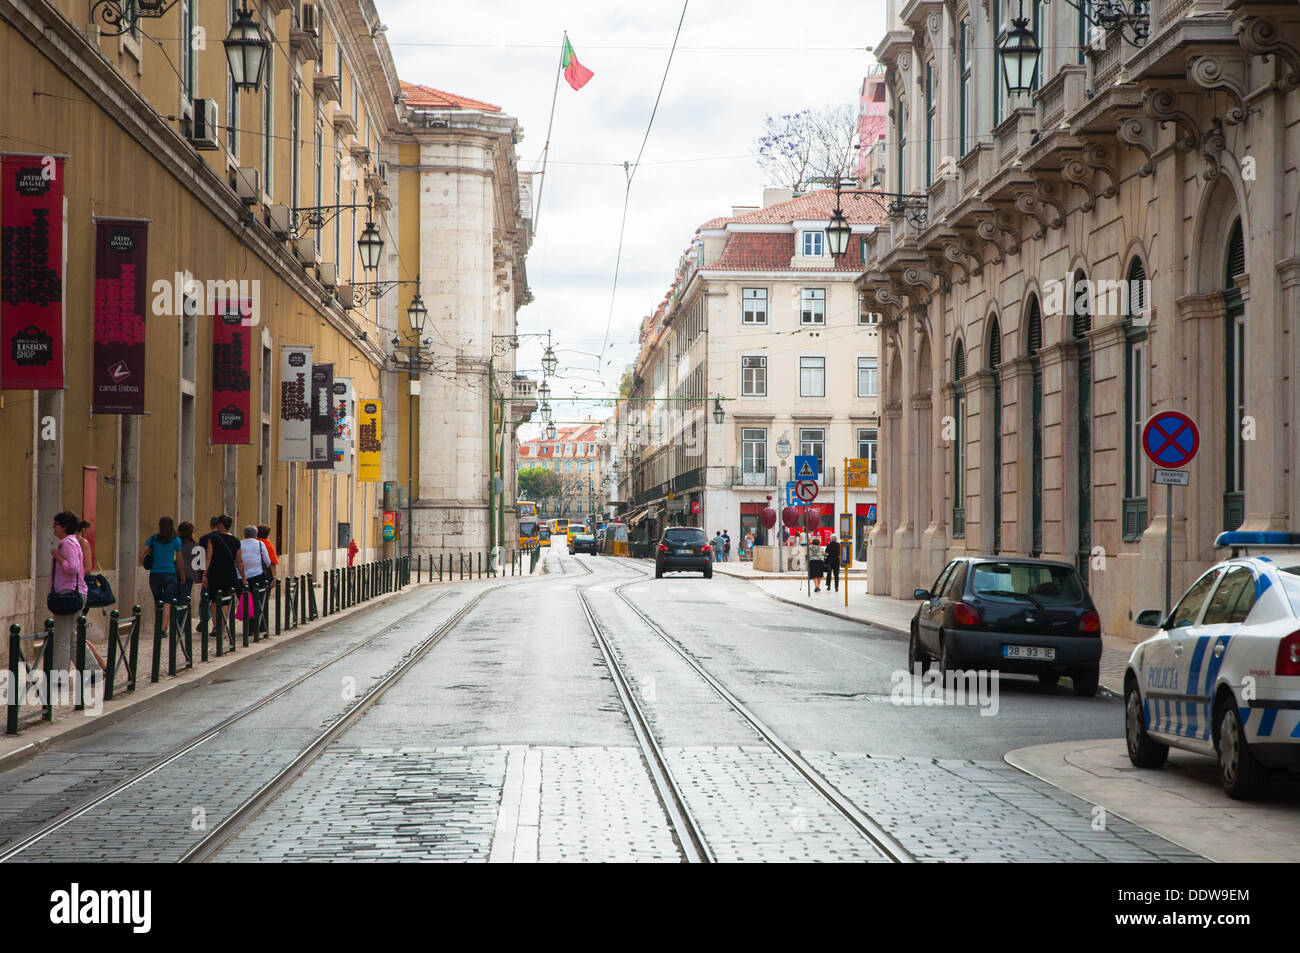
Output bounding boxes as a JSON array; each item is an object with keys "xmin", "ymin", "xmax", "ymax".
[{"xmin": 0, "ymin": 156, "xmax": 64, "ymax": 390}]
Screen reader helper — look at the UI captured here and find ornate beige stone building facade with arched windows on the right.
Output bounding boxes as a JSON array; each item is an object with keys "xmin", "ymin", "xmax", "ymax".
[{"xmin": 859, "ymin": 0, "xmax": 1300, "ymax": 637}]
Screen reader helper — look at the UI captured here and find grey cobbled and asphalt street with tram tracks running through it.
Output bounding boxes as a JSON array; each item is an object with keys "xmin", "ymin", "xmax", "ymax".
[{"xmin": 0, "ymin": 553, "xmax": 1201, "ymax": 862}]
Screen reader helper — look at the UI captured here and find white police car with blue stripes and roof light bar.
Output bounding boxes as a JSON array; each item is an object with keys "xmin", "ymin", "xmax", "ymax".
[{"xmin": 1125, "ymin": 533, "xmax": 1300, "ymax": 800}]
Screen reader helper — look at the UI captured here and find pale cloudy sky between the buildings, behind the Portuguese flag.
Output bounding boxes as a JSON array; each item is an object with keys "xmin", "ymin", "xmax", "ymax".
[{"xmin": 376, "ymin": 0, "xmax": 885, "ymax": 439}]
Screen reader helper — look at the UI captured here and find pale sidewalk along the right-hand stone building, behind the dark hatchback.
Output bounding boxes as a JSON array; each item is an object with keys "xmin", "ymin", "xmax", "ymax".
[{"xmin": 714, "ymin": 562, "xmax": 1134, "ymax": 696}]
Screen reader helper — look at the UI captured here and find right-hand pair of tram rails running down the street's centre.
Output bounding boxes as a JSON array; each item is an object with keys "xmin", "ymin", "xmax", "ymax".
[{"xmin": 579, "ymin": 551, "xmax": 917, "ymax": 863}]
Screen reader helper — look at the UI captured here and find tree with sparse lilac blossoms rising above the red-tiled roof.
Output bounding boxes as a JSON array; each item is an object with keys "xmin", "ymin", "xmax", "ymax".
[{"xmin": 754, "ymin": 105, "xmax": 858, "ymax": 192}]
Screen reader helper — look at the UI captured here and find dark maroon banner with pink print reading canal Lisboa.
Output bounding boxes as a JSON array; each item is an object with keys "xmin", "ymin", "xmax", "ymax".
[{"xmin": 91, "ymin": 220, "xmax": 150, "ymax": 413}]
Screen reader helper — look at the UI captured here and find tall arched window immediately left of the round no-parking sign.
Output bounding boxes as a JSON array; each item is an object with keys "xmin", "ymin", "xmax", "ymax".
[{"xmin": 1123, "ymin": 257, "xmax": 1151, "ymax": 542}]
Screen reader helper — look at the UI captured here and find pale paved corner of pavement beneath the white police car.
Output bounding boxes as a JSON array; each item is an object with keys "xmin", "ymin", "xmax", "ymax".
[{"xmin": 1005, "ymin": 738, "xmax": 1300, "ymax": 863}]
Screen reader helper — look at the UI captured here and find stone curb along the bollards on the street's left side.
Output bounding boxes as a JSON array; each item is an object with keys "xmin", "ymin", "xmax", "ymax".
[{"xmin": 0, "ymin": 582, "xmax": 416, "ymax": 771}]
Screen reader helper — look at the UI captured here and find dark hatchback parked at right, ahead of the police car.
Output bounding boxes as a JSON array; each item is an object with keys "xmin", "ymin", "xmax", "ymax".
[{"xmin": 907, "ymin": 556, "xmax": 1101, "ymax": 697}]
